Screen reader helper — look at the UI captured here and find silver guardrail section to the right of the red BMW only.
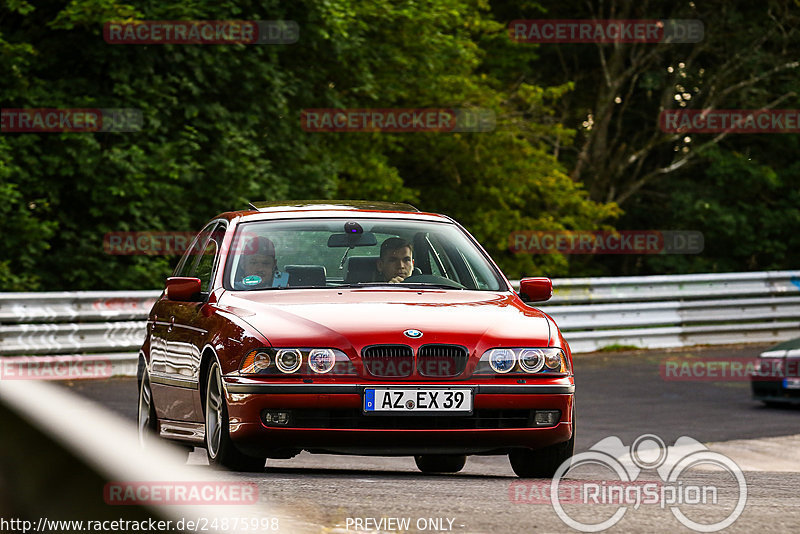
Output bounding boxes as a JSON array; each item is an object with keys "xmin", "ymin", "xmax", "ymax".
[{"xmin": 532, "ymin": 271, "xmax": 800, "ymax": 352}]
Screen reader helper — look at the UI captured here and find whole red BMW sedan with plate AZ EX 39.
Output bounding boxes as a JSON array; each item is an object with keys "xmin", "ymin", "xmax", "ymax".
[{"xmin": 138, "ymin": 201, "xmax": 575, "ymax": 477}]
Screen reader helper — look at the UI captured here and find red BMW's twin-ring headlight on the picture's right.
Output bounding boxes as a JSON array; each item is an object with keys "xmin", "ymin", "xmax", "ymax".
[{"xmin": 474, "ymin": 347, "xmax": 570, "ymax": 375}]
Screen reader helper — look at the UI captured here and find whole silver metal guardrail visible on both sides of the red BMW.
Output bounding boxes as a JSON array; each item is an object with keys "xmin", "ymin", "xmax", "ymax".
[{"xmin": 0, "ymin": 271, "xmax": 800, "ymax": 374}]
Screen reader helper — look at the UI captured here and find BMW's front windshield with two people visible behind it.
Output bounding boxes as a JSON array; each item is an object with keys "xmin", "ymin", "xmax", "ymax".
[{"xmin": 224, "ymin": 218, "xmax": 506, "ymax": 291}]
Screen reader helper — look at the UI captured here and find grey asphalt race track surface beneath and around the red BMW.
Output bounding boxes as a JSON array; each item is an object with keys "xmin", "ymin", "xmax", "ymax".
[{"xmin": 57, "ymin": 346, "xmax": 800, "ymax": 533}]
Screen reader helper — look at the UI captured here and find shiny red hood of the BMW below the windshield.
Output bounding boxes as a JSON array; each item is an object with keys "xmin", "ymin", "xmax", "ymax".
[{"xmin": 218, "ymin": 288, "xmax": 555, "ymax": 353}]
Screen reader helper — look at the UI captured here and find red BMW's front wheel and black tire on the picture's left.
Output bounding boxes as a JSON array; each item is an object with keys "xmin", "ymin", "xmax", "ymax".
[{"xmin": 205, "ymin": 362, "xmax": 267, "ymax": 471}]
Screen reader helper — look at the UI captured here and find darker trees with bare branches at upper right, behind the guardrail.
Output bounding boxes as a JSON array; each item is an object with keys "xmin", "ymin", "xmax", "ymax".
[{"xmin": 492, "ymin": 0, "xmax": 800, "ymax": 274}]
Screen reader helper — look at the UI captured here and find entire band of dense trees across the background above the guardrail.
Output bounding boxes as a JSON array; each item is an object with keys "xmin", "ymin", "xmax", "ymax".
[{"xmin": 0, "ymin": 0, "xmax": 800, "ymax": 291}]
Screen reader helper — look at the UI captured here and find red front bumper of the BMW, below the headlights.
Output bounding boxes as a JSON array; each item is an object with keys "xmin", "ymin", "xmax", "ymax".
[{"xmin": 225, "ymin": 377, "xmax": 575, "ymax": 456}]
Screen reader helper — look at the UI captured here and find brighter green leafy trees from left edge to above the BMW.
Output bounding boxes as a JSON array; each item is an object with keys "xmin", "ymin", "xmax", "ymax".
[{"xmin": 0, "ymin": 0, "xmax": 613, "ymax": 290}]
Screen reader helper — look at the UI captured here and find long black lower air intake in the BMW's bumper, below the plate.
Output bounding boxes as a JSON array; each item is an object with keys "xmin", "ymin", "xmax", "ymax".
[{"xmin": 289, "ymin": 410, "xmax": 536, "ymax": 430}]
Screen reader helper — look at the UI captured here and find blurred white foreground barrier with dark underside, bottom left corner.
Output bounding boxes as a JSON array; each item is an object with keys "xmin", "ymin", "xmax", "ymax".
[{"xmin": 0, "ymin": 380, "xmax": 294, "ymax": 534}]
